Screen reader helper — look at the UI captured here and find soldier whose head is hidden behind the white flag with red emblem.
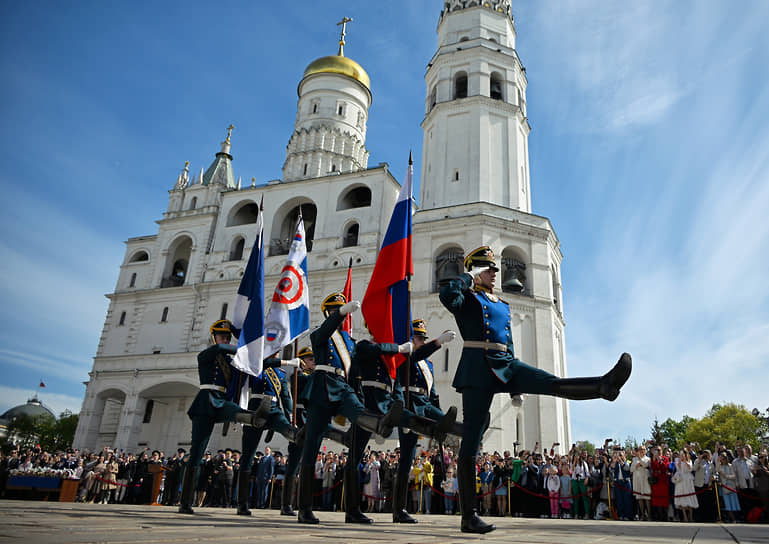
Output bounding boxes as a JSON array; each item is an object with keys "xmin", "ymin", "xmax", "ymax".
[{"xmin": 238, "ymin": 358, "xmax": 299, "ymax": 516}]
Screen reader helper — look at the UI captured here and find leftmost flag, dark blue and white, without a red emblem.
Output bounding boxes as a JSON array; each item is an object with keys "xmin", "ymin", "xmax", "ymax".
[{"xmin": 232, "ymin": 209, "xmax": 264, "ymax": 382}]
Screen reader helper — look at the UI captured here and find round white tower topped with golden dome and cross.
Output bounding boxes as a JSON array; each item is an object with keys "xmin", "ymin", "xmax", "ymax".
[{"xmin": 283, "ymin": 17, "xmax": 371, "ymax": 181}]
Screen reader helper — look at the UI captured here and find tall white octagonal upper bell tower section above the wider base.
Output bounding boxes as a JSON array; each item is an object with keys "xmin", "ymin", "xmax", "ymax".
[{"xmin": 420, "ymin": 0, "xmax": 531, "ymax": 213}]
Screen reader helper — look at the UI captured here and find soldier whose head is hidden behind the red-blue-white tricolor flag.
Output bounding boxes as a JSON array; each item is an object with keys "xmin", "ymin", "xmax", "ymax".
[{"xmin": 344, "ymin": 330, "xmax": 456, "ymax": 523}]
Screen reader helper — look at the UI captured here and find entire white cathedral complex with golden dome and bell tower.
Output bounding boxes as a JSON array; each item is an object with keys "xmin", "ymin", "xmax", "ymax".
[{"xmin": 73, "ymin": 0, "xmax": 571, "ymax": 452}]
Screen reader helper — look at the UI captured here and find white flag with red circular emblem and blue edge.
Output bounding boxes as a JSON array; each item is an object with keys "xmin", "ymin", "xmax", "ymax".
[{"xmin": 264, "ymin": 216, "xmax": 310, "ymax": 356}]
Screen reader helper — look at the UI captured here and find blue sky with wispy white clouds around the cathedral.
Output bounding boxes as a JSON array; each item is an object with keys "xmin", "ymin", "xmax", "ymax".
[{"xmin": 0, "ymin": 0, "xmax": 769, "ymax": 442}]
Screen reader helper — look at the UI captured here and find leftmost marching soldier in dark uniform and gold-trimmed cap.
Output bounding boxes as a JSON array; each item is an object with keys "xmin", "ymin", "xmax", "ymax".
[{"xmin": 179, "ymin": 319, "xmax": 269, "ymax": 514}]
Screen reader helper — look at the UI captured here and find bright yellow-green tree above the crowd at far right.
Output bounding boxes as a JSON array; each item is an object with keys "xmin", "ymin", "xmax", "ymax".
[{"xmin": 686, "ymin": 403, "xmax": 761, "ymax": 450}]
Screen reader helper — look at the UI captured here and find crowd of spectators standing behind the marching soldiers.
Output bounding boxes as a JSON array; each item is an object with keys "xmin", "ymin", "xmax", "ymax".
[{"xmin": 0, "ymin": 441, "xmax": 769, "ymax": 522}]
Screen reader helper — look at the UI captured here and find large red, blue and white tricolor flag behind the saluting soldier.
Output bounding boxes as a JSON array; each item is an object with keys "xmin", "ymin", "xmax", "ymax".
[{"xmin": 361, "ymin": 154, "xmax": 414, "ymax": 378}]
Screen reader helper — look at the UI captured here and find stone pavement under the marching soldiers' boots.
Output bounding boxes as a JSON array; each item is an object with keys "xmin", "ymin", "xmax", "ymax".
[{"xmin": 0, "ymin": 500, "xmax": 769, "ymax": 544}]
